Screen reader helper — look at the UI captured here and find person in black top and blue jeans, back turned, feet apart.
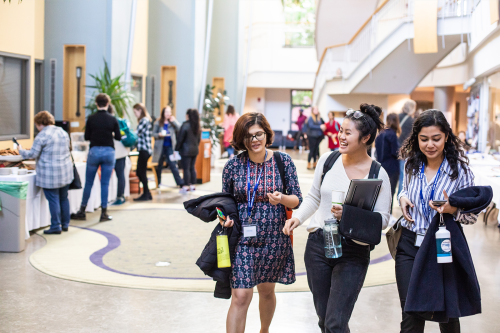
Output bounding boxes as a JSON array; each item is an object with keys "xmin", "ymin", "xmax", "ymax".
[{"xmin": 71, "ymin": 94, "xmax": 122, "ymax": 222}]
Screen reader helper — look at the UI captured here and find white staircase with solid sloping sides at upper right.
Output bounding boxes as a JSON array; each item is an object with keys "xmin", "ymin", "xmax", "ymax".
[{"xmin": 313, "ymin": 0, "xmax": 478, "ymax": 105}]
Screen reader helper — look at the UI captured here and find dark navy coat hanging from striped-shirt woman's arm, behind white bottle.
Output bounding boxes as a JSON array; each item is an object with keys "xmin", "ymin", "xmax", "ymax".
[{"xmin": 404, "ymin": 211, "xmax": 481, "ymax": 323}]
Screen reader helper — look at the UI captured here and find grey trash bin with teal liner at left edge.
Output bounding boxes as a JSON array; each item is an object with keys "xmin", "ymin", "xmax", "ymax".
[{"xmin": 0, "ymin": 181, "xmax": 29, "ymax": 252}]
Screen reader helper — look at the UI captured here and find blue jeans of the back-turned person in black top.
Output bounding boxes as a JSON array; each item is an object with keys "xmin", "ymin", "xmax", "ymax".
[{"xmin": 82, "ymin": 146, "xmax": 115, "ymax": 208}]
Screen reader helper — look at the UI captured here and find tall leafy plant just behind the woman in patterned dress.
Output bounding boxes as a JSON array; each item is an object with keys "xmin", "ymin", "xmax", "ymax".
[{"xmin": 201, "ymin": 84, "xmax": 229, "ymax": 147}]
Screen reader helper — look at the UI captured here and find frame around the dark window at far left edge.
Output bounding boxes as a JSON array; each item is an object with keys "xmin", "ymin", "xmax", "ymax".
[{"xmin": 0, "ymin": 51, "xmax": 32, "ymax": 141}]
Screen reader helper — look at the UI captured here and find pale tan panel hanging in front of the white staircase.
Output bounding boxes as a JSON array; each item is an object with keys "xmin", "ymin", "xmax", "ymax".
[{"xmin": 413, "ymin": 0, "xmax": 438, "ymax": 54}]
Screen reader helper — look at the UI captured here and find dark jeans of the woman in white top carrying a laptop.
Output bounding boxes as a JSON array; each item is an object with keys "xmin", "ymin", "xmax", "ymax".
[{"xmin": 304, "ymin": 229, "xmax": 370, "ymax": 333}]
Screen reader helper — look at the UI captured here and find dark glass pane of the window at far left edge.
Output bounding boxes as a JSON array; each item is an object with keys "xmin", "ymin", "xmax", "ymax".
[{"xmin": 0, "ymin": 54, "xmax": 30, "ymax": 140}]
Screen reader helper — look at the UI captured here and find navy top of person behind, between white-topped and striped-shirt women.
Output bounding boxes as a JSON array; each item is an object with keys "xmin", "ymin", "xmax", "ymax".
[{"xmin": 375, "ymin": 128, "xmax": 399, "ymax": 176}]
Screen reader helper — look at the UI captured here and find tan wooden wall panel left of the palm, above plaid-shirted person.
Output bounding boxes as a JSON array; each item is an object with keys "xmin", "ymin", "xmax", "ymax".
[{"xmin": 63, "ymin": 45, "xmax": 86, "ymax": 132}]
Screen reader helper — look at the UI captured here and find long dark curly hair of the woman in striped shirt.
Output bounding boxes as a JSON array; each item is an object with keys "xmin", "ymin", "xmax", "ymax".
[{"xmin": 399, "ymin": 110, "xmax": 469, "ymax": 180}]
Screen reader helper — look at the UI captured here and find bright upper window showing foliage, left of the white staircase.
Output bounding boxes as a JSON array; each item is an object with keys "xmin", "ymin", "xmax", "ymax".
[{"xmin": 283, "ymin": 0, "xmax": 316, "ymax": 47}]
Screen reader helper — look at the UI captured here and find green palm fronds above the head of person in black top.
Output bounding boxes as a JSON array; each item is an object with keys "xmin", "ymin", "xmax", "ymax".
[{"xmin": 85, "ymin": 60, "xmax": 134, "ymax": 118}]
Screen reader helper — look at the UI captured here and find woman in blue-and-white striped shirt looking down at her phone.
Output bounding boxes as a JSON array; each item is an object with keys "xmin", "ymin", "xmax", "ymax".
[{"xmin": 396, "ymin": 110, "xmax": 477, "ymax": 333}]
